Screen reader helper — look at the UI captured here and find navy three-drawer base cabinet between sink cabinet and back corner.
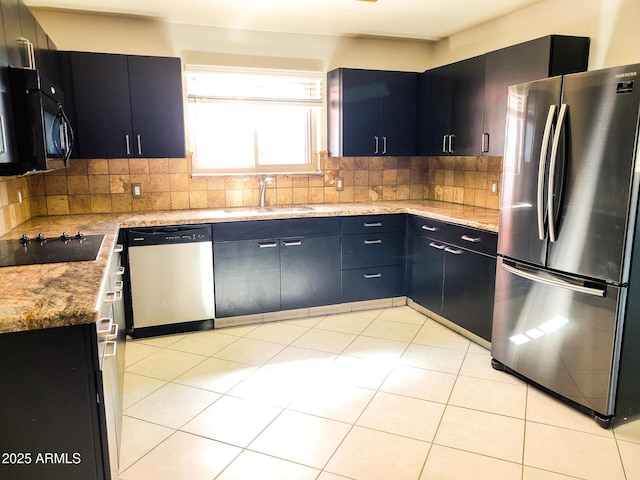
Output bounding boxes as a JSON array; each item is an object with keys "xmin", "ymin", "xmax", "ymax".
[{"xmin": 341, "ymin": 214, "xmax": 406, "ymax": 303}]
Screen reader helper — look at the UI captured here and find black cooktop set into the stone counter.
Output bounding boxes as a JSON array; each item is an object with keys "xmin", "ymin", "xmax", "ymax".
[{"xmin": 0, "ymin": 232, "xmax": 104, "ymax": 267}]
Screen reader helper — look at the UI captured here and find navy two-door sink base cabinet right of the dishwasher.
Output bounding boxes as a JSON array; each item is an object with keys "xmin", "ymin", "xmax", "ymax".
[{"xmin": 213, "ymin": 217, "xmax": 340, "ymax": 318}]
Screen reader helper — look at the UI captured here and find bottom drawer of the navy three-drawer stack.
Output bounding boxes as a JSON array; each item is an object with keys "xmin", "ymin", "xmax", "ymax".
[{"xmin": 342, "ymin": 265, "xmax": 404, "ymax": 302}]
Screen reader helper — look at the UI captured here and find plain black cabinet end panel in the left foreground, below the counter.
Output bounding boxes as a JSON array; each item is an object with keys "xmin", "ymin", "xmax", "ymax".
[{"xmin": 0, "ymin": 325, "xmax": 106, "ymax": 480}]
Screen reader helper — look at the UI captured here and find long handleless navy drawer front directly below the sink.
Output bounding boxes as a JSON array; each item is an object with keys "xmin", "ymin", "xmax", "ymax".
[{"xmin": 213, "ymin": 217, "xmax": 340, "ymax": 243}]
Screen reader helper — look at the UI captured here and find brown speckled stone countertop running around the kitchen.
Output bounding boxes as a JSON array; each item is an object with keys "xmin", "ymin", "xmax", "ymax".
[{"xmin": 0, "ymin": 201, "xmax": 499, "ymax": 333}]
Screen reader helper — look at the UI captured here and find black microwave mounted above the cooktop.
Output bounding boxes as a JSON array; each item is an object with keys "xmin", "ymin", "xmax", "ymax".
[{"xmin": 9, "ymin": 67, "xmax": 74, "ymax": 175}]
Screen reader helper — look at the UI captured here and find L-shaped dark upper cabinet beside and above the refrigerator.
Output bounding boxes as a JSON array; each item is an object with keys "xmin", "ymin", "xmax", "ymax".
[{"xmin": 483, "ymin": 35, "xmax": 589, "ymax": 156}]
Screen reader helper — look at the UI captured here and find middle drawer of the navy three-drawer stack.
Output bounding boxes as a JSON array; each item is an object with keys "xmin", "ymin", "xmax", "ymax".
[{"xmin": 342, "ymin": 232, "xmax": 404, "ymax": 269}]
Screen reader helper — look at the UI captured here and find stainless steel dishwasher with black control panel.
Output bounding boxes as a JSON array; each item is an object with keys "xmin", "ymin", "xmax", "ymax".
[{"xmin": 127, "ymin": 225, "xmax": 215, "ymax": 337}]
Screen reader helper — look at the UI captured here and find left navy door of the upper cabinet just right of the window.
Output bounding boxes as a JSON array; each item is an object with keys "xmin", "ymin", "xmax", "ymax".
[{"xmin": 340, "ymin": 69, "xmax": 382, "ymax": 157}]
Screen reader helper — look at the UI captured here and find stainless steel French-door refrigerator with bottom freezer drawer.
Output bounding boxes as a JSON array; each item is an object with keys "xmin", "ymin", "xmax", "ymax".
[{"xmin": 491, "ymin": 65, "xmax": 640, "ymax": 427}]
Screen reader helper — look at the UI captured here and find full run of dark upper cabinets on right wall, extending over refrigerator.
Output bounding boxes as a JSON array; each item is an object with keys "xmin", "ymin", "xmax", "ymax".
[{"xmin": 416, "ymin": 35, "xmax": 589, "ymax": 156}]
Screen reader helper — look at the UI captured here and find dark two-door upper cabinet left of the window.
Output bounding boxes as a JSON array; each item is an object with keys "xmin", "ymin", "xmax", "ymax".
[{"xmin": 70, "ymin": 52, "xmax": 185, "ymax": 158}]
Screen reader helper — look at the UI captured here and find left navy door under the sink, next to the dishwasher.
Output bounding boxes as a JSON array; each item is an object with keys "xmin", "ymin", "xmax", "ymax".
[{"xmin": 213, "ymin": 240, "xmax": 280, "ymax": 318}]
